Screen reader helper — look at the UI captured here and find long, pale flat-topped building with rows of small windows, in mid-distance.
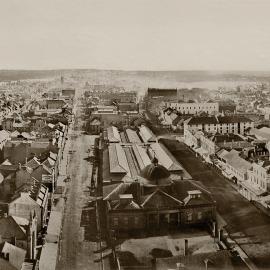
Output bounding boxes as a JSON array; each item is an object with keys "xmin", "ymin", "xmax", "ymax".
[{"xmin": 165, "ymin": 101, "xmax": 219, "ymax": 114}]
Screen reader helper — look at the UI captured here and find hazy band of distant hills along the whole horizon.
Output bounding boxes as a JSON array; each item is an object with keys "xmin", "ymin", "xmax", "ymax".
[{"xmin": 0, "ymin": 69, "xmax": 270, "ymax": 92}]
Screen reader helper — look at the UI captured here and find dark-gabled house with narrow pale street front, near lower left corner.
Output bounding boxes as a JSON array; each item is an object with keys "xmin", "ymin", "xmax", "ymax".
[{"xmin": 0, "ymin": 213, "xmax": 37, "ymax": 260}]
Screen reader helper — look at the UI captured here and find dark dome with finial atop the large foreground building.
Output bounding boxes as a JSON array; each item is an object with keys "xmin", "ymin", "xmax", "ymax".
[{"xmin": 140, "ymin": 158, "xmax": 171, "ymax": 185}]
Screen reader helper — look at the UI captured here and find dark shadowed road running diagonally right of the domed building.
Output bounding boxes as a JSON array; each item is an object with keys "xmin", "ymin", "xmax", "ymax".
[{"xmin": 161, "ymin": 141, "xmax": 270, "ymax": 269}]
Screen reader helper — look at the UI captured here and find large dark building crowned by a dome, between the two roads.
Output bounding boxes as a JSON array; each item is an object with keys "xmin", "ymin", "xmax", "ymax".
[{"xmin": 103, "ymin": 158, "xmax": 216, "ymax": 232}]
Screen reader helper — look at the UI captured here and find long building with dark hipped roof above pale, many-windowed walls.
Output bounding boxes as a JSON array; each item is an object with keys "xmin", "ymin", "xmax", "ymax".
[{"xmin": 184, "ymin": 115, "xmax": 254, "ymax": 134}]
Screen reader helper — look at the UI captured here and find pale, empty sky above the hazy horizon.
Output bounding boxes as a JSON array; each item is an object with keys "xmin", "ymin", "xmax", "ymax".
[{"xmin": 0, "ymin": 0, "xmax": 270, "ymax": 71}]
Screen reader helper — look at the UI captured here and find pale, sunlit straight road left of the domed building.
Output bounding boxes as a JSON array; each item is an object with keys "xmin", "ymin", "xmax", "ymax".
[{"xmin": 57, "ymin": 100, "xmax": 100, "ymax": 270}]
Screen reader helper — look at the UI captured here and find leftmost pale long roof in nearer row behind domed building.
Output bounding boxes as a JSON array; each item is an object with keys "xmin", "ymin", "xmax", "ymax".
[{"xmin": 109, "ymin": 143, "xmax": 130, "ymax": 175}]
